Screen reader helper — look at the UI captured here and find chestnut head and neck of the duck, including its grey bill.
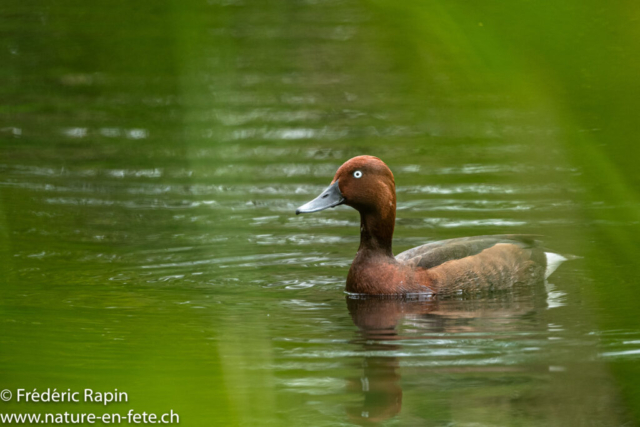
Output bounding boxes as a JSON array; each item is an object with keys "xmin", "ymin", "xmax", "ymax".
[{"xmin": 296, "ymin": 156, "xmax": 396, "ymax": 252}]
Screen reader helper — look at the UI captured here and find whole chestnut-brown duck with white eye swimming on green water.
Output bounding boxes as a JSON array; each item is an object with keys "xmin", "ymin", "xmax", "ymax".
[{"xmin": 296, "ymin": 155, "xmax": 566, "ymax": 295}]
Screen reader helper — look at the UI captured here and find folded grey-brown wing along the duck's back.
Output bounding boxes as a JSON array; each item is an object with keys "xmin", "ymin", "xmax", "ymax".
[{"xmin": 396, "ymin": 234, "xmax": 540, "ymax": 269}]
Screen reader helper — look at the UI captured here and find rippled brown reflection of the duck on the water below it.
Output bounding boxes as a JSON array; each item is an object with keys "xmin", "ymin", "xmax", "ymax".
[{"xmin": 346, "ymin": 286, "xmax": 546, "ymax": 424}]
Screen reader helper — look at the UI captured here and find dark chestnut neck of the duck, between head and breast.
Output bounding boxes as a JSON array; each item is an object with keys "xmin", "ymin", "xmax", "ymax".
[{"xmin": 358, "ymin": 205, "xmax": 396, "ymax": 259}]
